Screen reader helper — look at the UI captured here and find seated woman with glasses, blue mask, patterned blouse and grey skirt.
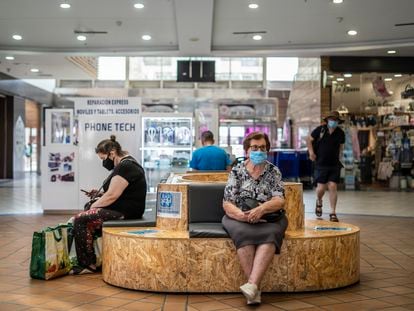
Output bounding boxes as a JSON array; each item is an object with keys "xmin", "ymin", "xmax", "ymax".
[{"xmin": 222, "ymin": 132, "xmax": 288, "ymax": 304}]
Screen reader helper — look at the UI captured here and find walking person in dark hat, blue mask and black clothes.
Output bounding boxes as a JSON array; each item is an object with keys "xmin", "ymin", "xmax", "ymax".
[{"xmin": 307, "ymin": 111, "xmax": 345, "ymax": 222}]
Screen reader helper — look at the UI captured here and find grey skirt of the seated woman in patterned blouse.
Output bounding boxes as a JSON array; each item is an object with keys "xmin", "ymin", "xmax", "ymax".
[{"xmin": 221, "ymin": 215, "xmax": 288, "ymax": 254}]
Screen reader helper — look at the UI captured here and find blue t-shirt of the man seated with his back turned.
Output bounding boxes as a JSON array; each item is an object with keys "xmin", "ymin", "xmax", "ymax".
[{"xmin": 190, "ymin": 145, "xmax": 231, "ymax": 171}]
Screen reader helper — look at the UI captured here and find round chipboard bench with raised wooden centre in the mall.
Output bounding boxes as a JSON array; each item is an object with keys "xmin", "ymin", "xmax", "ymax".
[{"xmin": 102, "ymin": 173, "xmax": 359, "ymax": 292}]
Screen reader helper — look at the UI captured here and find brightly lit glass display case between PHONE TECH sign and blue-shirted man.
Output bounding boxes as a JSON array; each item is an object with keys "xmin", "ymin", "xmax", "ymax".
[{"xmin": 141, "ymin": 113, "xmax": 193, "ymax": 192}]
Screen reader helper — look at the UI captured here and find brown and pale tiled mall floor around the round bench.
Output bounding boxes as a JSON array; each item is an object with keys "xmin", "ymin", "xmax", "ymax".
[{"xmin": 0, "ymin": 177, "xmax": 414, "ymax": 311}]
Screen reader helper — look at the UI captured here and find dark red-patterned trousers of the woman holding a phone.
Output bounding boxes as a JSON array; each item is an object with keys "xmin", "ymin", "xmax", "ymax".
[{"xmin": 73, "ymin": 208, "xmax": 124, "ymax": 267}]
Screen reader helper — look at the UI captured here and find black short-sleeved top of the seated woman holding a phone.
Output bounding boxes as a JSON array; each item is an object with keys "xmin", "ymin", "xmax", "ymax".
[{"xmin": 103, "ymin": 156, "xmax": 147, "ymax": 219}]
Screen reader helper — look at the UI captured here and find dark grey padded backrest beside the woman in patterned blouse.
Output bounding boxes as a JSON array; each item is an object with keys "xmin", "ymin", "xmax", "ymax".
[{"xmin": 188, "ymin": 183, "xmax": 226, "ymax": 223}]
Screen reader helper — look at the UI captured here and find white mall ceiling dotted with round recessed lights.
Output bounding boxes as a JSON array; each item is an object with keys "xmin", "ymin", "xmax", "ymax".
[{"xmin": 0, "ymin": 0, "xmax": 414, "ymax": 79}]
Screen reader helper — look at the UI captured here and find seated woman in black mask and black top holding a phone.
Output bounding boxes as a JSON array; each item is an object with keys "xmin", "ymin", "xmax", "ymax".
[{"xmin": 73, "ymin": 135, "xmax": 147, "ymax": 272}]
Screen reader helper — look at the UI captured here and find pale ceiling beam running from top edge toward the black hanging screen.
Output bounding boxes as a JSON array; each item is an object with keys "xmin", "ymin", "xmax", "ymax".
[{"xmin": 175, "ymin": 0, "xmax": 214, "ymax": 56}]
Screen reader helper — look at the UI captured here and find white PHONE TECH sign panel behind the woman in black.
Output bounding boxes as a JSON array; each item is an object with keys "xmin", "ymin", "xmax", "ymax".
[{"xmin": 73, "ymin": 98, "xmax": 141, "ymax": 206}]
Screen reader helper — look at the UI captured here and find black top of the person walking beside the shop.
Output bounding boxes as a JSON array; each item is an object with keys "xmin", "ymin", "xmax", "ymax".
[{"xmin": 311, "ymin": 125, "xmax": 345, "ymax": 167}]
